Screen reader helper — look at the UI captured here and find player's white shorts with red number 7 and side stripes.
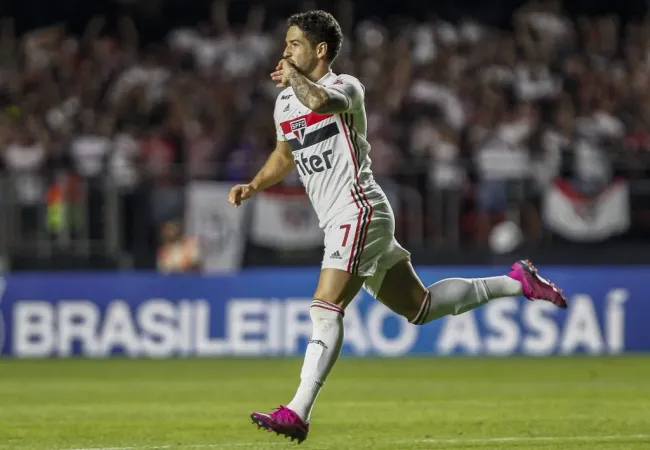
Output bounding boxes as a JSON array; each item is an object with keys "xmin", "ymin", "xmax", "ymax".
[{"xmin": 322, "ymin": 203, "xmax": 411, "ymax": 298}]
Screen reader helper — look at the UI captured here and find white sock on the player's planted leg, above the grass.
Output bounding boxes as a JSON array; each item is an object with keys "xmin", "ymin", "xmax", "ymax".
[{"xmin": 287, "ymin": 300, "xmax": 343, "ymax": 422}]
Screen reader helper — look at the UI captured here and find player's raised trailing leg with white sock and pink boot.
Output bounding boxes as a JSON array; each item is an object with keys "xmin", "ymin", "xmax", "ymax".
[{"xmin": 369, "ymin": 255, "xmax": 566, "ymax": 325}]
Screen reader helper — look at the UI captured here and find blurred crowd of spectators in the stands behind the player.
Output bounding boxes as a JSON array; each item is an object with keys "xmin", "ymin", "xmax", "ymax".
[{"xmin": 0, "ymin": 0, "xmax": 650, "ymax": 268}]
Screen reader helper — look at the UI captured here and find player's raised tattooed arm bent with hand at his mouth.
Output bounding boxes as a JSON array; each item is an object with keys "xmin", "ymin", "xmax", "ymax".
[{"xmin": 287, "ymin": 67, "xmax": 363, "ymax": 114}]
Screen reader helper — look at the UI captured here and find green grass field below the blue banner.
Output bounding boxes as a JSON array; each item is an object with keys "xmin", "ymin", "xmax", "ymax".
[{"xmin": 0, "ymin": 356, "xmax": 650, "ymax": 450}]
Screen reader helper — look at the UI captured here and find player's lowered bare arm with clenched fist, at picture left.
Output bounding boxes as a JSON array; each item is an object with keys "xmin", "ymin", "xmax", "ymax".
[{"xmin": 228, "ymin": 139, "xmax": 296, "ymax": 206}]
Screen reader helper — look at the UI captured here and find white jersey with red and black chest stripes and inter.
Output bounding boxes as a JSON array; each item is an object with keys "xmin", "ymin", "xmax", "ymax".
[{"xmin": 274, "ymin": 71, "xmax": 387, "ymax": 229}]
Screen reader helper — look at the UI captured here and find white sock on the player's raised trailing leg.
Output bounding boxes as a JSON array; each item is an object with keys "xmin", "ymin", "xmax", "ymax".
[{"xmin": 411, "ymin": 275, "xmax": 523, "ymax": 325}]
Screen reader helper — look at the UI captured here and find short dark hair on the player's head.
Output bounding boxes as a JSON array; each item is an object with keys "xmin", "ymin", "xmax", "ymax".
[{"xmin": 287, "ymin": 10, "xmax": 343, "ymax": 63}]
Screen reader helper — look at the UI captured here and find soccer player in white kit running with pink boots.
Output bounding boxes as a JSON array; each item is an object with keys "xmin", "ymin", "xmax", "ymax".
[{"xmin": 229, "ymin": 11, "xmax": 567, "ymax": 442}]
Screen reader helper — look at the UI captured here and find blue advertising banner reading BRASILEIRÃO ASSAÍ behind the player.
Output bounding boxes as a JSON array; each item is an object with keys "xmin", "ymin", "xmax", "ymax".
[{"xmin": 0, "ymin": 267, "xmax": 650, "ymax": 358}]
